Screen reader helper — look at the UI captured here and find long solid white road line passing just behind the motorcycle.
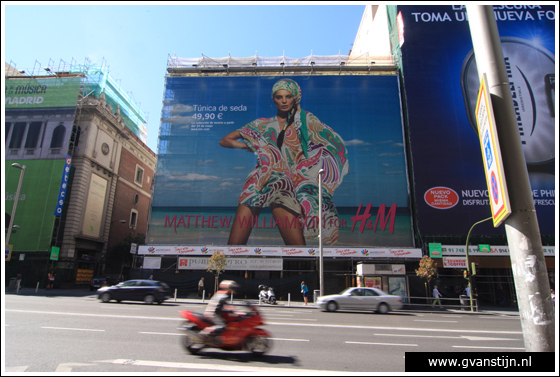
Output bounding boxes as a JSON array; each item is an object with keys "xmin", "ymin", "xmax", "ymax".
[{"xmin": 4, "ymin": 309, "xmax": 523, "ymax": 335}]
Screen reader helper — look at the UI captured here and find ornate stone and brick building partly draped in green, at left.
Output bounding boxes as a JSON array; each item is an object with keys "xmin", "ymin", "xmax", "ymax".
[{"xmin": 5, "ymin": 60, "xmax": 156, "ymax": 287}]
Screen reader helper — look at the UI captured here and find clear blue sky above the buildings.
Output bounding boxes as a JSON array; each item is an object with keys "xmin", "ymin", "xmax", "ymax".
[{"xmin": 2, "ymin": 2, "xmax": 366, "ymax": 152}]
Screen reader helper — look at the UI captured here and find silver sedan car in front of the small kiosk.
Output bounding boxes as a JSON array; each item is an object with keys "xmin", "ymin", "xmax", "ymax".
[{"xmin": 317, "ymin": 288, "xmax": 402, "ymax": 314}]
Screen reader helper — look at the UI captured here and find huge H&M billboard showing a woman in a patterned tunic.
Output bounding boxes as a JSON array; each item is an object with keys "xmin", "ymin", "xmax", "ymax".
[{"xmin": 147, "ymin": 75, "xmax": 413, "ymax": 247}]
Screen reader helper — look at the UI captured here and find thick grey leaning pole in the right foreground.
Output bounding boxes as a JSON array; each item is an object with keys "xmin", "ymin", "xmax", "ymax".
[{"xmin": 466, "ymin": 5, "xmax": 555, "ymax": 352}]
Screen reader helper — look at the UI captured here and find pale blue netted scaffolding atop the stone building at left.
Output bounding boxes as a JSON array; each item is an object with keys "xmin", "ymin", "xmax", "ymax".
[{"xmin": 5, "ymin": 58, "xmax": 148, "ymax": 143}]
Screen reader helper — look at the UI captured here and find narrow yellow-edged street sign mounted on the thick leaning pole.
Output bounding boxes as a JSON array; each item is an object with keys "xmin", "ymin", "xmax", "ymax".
[{"xmin": 476, "ymin": 73, "xmax": 511, "ymax": 227}]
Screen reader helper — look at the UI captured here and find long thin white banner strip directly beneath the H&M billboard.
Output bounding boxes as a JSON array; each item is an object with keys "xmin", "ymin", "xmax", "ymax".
[{"xmin": 138, "ymin": 245, "xmax": 422, "ymax": 258}]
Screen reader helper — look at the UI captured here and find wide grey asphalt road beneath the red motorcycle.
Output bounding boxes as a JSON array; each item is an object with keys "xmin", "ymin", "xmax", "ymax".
[{"xmin": 3, "ymin": 294, "xmax": 524, "ymax": 374}]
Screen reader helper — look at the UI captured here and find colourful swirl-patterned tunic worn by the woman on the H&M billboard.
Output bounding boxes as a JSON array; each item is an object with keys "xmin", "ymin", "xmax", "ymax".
[{"xmin": 239, "ymin": 110, "xmax": 348, "ymax": 245}]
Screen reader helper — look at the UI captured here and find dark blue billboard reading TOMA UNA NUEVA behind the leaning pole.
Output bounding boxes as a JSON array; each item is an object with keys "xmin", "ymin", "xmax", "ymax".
[{"xmin": 397, "ymin": 5, "xmax": 557, "ymax": 236}]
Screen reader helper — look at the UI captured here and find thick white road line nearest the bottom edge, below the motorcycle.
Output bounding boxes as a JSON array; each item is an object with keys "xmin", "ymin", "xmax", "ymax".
[{"xmin": 96, "ymin": 359, "xmax": 348, "ymax": 375}]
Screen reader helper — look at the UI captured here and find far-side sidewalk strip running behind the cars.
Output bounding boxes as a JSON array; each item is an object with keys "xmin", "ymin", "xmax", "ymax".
[{"xmin": 6, "ymin": 288, "xmax": 519, "ymax": 316}]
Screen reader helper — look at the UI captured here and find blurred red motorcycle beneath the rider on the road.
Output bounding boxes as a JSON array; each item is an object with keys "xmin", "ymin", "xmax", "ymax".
[{"xmin": 179, "ymin": 305, "xmax": 272, "ymax": 355}]
